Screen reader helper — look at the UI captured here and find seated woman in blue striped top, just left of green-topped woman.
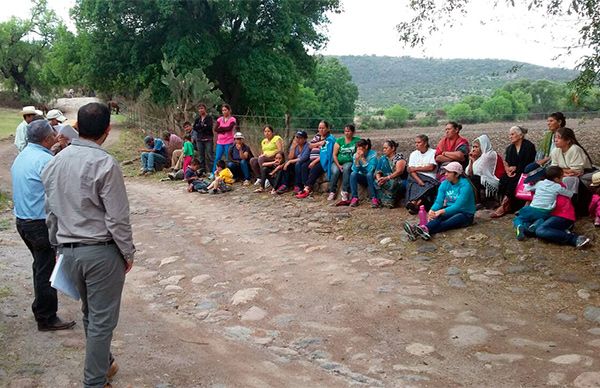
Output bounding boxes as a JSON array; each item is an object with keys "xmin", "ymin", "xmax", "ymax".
[{"xmin": 296, "ymin": 121, "xmax": 335, "ymax": 199}]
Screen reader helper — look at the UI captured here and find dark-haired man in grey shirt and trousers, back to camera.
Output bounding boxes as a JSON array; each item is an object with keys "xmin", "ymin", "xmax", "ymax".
[{"xmin": 42, "ymin": 103, "xmax": 135, "ymax": 387}]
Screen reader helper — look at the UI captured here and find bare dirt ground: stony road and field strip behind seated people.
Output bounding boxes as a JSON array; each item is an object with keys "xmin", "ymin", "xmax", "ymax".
[{"xmin": 0, "ymin": 104, "xmax": 600, "ymax": 387}]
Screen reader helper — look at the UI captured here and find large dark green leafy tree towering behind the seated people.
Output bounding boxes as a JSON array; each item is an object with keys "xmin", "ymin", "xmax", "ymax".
[{"xmin": 73, "ymin": 0, "xmax": 340, "ymax": 115}]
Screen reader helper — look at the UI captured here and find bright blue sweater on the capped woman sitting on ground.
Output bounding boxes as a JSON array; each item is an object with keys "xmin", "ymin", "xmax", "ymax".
[{"xmin": 431, "ymin": 176, "xmax": 475, "ymax": 217}]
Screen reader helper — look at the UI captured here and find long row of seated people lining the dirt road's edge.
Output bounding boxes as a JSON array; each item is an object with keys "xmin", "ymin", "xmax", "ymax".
[{"xmin": 149, "ymin": 106, "xmax": 600, "ymax": 246}]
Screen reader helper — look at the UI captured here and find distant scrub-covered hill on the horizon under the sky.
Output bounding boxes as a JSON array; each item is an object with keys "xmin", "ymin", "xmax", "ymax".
[{"xmin": 337, "ymin": 56, "xmax": 578, "ymax": 110}]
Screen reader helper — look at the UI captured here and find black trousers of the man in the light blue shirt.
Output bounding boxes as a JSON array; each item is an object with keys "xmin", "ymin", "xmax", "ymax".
[{"xmin": 17, "ymin": 218, "xmax": 58, "ymax": 324}]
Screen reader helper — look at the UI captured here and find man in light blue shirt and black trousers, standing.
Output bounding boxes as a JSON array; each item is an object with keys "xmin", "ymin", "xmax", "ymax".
[{"xmin": 10, "ymin": 120, "xmax": 75, "ymax": 331}]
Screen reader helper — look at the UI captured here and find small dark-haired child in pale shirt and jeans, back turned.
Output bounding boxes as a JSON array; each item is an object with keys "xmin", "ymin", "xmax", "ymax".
[{"xmin": 513, "ymin": 166, "xmax": 573, "ymax": 241}]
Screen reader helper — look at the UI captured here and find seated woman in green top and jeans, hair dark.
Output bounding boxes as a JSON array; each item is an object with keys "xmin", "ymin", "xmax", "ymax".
[{"xmin": 327, "ymin": 124, "xmax": 360, "ymax": 201}]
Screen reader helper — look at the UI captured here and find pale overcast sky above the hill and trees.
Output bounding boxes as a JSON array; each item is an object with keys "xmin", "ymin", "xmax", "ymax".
[{"xmin": 0, "ymin": 0, "xmax": 582, "ymax": 68}]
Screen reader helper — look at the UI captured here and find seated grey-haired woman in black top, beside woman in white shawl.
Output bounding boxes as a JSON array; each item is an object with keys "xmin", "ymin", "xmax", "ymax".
[{"xmin": 492, "ymin": 126, "xmax": 535, "ymax": 218}]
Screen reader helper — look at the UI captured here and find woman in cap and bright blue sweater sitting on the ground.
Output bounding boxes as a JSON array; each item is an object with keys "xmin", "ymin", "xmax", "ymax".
[{"xmin": 404, "ymin": 162, "xmax": 475, "ymax": 241}]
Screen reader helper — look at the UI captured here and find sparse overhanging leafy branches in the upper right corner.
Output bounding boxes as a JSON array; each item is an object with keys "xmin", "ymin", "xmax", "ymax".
[{"xmin": 396, "ymin": 0, "xmax": 600, "ymax": 90}]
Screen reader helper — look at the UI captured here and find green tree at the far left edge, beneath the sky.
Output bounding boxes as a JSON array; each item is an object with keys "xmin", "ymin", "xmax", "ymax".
[{"xmin": 0, "ymin": 0, "xmax": 58, "ymax": 97}]
